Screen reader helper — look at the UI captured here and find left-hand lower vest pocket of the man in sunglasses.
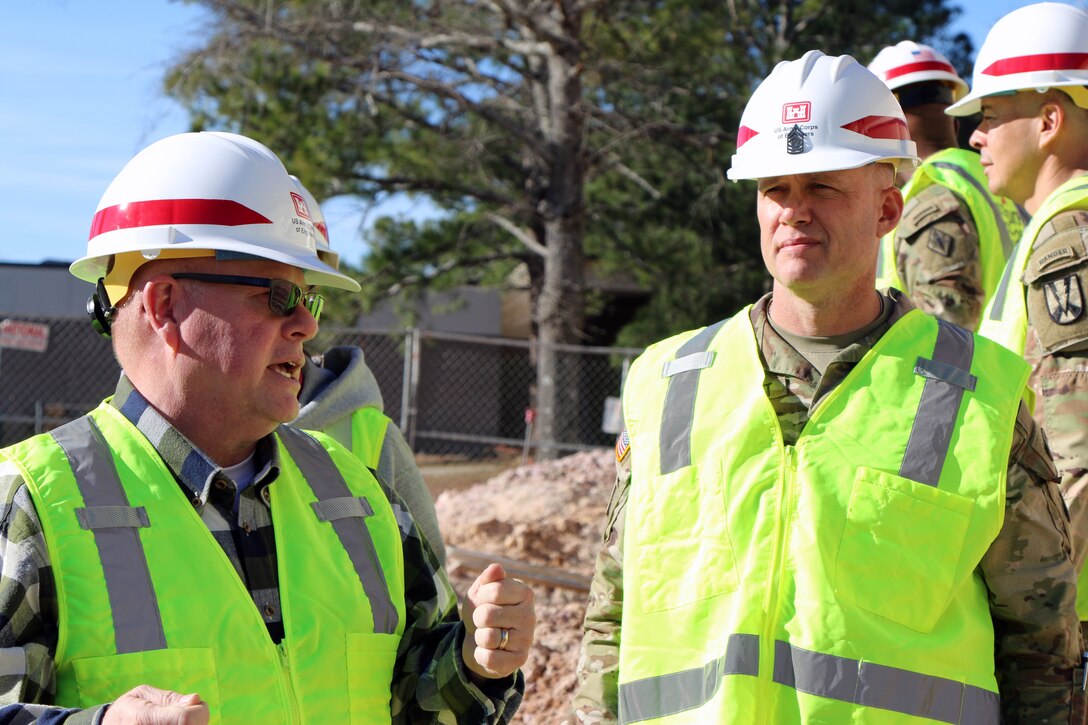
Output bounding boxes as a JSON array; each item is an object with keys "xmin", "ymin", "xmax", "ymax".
[{"xmin": 72, "ymin": 649, "xmax": 222, "ymax": 723}]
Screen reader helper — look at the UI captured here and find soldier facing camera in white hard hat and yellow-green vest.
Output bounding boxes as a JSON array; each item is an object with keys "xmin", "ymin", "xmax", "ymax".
[{"xmin": 572, "ymin": 51, "xmax": 1080, "ymax": 725}]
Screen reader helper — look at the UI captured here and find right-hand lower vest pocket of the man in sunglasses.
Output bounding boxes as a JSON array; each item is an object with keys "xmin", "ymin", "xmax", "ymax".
[{"xmin": 347, "ymin": 632, "xmax": 400, "ymax": 723}]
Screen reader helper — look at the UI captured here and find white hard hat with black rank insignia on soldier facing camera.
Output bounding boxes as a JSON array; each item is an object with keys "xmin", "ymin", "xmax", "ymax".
[{"xmin": 728, "ymin": 50, "xmax": 918, "ymax": 181}]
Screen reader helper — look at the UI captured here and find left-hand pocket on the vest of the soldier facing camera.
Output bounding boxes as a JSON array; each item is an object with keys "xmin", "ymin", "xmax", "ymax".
[{"xmin": 627, "ymin": 466, "xmax": 738, "ymax": 612}]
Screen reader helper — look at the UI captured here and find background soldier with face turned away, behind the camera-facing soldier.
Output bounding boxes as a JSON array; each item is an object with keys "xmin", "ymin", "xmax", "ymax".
[{"xmin": 868, "ymin": 40, "xmax": 1026, "ymax": 330}]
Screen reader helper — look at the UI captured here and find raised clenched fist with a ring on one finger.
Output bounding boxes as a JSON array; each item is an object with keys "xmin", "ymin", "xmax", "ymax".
[{"xmin": 461, "ymin": 564, "xmax": 536, "ymax": 679}]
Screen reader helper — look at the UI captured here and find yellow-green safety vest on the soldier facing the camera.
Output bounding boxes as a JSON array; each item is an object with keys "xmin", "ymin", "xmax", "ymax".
[{"xmin": 619, "ymin": 308, "xmax": 1029, "ymax": 725}]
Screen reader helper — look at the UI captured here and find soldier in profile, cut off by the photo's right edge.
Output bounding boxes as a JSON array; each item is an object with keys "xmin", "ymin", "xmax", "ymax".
[{"xmin": 949, "ymin": 2, "xmax": 1088, "ymax": 630}]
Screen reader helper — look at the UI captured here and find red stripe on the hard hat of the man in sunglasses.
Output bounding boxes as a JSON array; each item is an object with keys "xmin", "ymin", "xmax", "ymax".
[{"xmin": 90, "ymin": 199, "xmax": 272, "ymax": 238}]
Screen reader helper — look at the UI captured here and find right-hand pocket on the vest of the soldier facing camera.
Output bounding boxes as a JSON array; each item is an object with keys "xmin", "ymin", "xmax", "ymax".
[{"xmin": 834, "ymin": 467, "xmax": 975, "ymax": 632}]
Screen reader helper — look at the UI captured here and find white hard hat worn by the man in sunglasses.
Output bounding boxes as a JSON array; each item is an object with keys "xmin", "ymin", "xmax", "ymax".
[{"xmin": 70, "ymin": 133, "xmax": 359, "ymax": 297}]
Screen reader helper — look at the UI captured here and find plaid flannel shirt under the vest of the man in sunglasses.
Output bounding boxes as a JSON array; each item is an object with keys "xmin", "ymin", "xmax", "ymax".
[{"xmin": 0, "ymin": 376, "xmax": 524, "ymax": 724}]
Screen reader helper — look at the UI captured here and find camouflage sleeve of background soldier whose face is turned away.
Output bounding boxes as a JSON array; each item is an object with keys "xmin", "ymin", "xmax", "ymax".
[{"xmin": 894, "ymin": 184, "xmax": 986, "ymax": 330}]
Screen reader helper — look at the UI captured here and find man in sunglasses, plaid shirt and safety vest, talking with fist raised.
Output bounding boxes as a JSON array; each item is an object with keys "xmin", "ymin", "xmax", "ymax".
[{"xmin": 0, "ymin": 133, "xmax": 534, "ymax": 725}]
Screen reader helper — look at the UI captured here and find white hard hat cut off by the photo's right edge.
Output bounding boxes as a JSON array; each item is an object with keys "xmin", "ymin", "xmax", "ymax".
[{"xmin": 948, "ymin": 2, "xmax": 1088, "ymax": 115}]
